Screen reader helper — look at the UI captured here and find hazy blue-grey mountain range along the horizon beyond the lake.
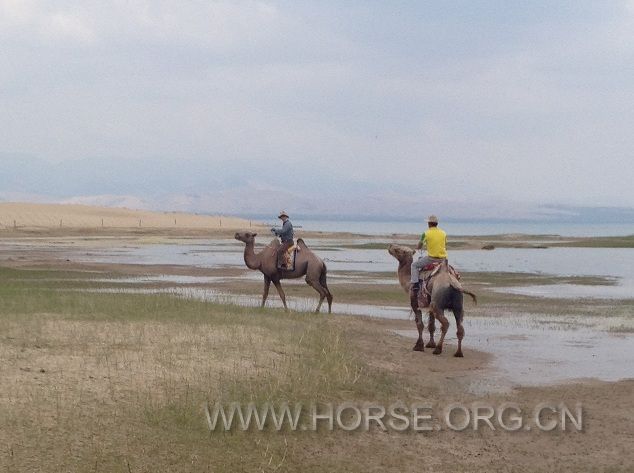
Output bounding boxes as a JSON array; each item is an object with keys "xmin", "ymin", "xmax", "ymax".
[{"xmin": 0, "ymin": 154, "xmax": 634, "ymax": 225}]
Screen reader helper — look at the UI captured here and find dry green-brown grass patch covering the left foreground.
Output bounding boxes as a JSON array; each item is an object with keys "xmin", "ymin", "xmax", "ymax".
[{"xmin": 0, "ymin": 269, "xmax": 397, "ymax": 472}]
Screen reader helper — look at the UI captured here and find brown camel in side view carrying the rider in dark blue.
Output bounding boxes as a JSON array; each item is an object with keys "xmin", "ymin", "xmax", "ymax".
[{"xmin": 235, "ymin": 232, "xmax": 332, "ymax": 314}]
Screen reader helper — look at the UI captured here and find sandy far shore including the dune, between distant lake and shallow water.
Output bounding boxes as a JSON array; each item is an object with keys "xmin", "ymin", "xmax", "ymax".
[{"xmin": 0, "ymin": 202, "xmax": 634, "ymax": 251}]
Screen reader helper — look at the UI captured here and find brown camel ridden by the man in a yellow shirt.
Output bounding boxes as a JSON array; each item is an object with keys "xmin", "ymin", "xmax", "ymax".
[{"xmin": 388, "ymin": 245, "xmax": 477, "ymax": 358}]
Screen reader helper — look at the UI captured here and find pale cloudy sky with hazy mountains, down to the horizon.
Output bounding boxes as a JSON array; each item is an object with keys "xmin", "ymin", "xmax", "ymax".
[{"xmin": 0, "ymin": 0, "xmax": 634, "ymax": 218}]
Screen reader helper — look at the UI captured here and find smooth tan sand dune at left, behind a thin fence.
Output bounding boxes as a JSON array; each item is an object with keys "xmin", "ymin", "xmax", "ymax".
[{"xmin": 0, "ymin": 202, "xmax": 259, "ymax": 229}]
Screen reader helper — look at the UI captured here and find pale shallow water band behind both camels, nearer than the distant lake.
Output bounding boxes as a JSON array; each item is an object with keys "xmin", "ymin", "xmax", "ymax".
[{"xmin": 65, "ymin": 240, "xmax": 634, "ymax": 299}]
